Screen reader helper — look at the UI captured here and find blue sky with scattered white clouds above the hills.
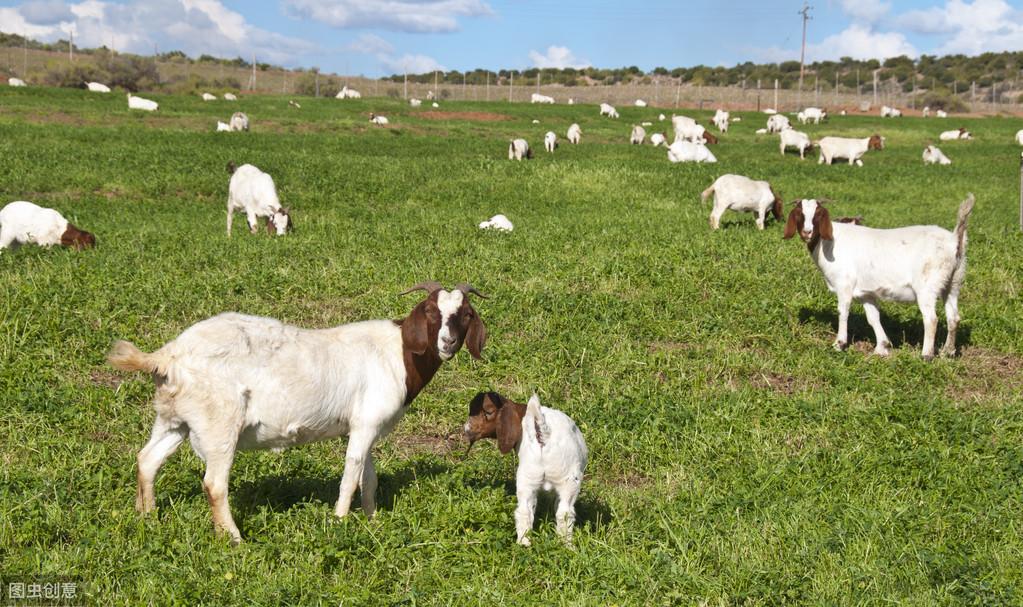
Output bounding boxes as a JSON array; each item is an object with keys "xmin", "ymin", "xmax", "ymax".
[{"xmin": 0, "ymin": 0, "xmax": 1023, "ymax": 77}]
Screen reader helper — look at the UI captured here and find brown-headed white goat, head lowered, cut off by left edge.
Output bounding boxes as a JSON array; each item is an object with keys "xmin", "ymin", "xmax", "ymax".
[{"xmin": 0, "ymin": 201, "xmax": 96, "ymax": 251}]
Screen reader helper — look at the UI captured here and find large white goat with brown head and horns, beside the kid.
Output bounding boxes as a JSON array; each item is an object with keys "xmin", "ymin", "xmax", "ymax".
[{"xmin": 114, "ymin": 283, "xmax": 487, "ymax": 544}]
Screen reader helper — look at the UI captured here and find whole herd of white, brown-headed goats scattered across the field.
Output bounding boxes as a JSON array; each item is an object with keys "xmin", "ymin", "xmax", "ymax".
[{"xmin": 0, "ymin": 83, "xmax": 1023, "ymax": 545}]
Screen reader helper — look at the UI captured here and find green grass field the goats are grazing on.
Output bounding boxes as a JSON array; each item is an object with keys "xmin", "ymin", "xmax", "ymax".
[{"xmin": 0, "ymin": 87, "xmax": 1023, "ymax": 606}]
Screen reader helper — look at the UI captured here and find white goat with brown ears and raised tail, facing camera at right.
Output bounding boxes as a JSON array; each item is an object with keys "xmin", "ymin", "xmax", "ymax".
[{"xmin": 784, "ymin": 193, "xmax": 974, "ymax": 360}]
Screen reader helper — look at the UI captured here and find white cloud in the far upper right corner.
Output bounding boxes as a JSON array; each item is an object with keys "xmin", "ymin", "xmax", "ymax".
[{"xmin": 896, "ymin": 0, "xmax": 1023, "ymax": 54}]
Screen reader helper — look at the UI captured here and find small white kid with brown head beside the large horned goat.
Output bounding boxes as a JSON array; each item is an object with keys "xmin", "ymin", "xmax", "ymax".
[{"xmin": 464, "ymin": 392, "xmax": 589, "ymax": 546}]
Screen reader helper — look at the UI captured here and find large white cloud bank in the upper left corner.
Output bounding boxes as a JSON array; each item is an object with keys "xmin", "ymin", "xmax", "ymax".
[{"xmin": 0, "ymin": 0, "xmax": 315, "ymax": 62}]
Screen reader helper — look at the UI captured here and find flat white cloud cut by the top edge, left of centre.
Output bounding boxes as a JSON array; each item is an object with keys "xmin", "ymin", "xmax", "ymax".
[{"xmin": 283, "ymin": 0, "xmax": 493, "ymax": 33}]
